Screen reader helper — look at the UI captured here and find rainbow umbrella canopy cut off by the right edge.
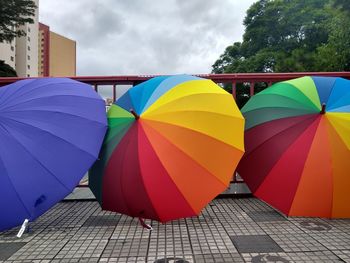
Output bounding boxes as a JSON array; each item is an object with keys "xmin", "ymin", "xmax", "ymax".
[{"xmin": 238, "ymin": 77, "xmax": 350, "ymax": 218}]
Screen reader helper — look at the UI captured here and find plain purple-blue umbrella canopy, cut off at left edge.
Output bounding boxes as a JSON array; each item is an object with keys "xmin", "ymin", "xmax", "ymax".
[{"xmin": 0, "ymin": 78, "xmax": 107, "ymax": 231}]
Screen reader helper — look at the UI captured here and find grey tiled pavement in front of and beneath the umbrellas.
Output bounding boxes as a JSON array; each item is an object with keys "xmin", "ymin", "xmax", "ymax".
[{"xmin": 0, "ymin": 198, "xmax": 350, "ymax": 263}]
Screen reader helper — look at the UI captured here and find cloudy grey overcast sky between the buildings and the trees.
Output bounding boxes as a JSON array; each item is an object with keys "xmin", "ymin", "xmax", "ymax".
[{"xmin": 39, "ymin": 0, "xmax": 255, "ymax": 75}]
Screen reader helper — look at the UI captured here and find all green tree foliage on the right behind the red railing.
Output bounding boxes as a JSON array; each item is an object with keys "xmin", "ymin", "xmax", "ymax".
[{"xmin": 212, "ymin": 0, "xmax": 350, "ymax": 106}]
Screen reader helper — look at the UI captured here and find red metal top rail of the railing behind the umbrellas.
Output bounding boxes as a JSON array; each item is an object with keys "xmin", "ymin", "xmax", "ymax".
[{"xmin": 0, "ymin": 72, "xmax": 350, "ymax": 100}]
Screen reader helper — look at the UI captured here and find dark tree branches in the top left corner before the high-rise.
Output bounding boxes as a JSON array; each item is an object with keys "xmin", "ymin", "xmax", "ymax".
[{"xmin": 0, "ymin": 0, "xmax": 36, "ymax": 42}]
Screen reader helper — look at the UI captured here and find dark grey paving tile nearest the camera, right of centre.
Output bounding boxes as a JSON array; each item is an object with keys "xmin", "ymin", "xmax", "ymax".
[{"xmin": 231, "ymin": 235, "xmax": 283, "ymax": 253}]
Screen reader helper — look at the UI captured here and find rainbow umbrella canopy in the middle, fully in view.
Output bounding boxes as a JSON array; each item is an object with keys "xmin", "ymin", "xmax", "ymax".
[{"xmin": 89, "ymin": 75, "xmax": 244, "ymax": 222}]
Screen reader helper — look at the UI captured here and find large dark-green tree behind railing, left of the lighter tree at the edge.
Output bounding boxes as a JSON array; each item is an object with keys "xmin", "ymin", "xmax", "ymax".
[{"xmin": 213, "ymin": 0, "xmax": 334, "ymax": 73}]
